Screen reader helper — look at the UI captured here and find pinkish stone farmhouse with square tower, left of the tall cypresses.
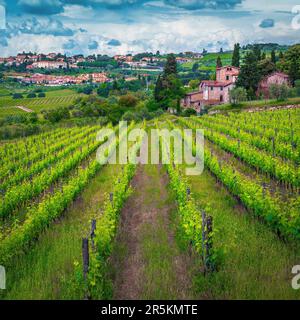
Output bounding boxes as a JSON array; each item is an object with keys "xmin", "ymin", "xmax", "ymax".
[{"xmin": 181, "ymin": 66, "xmax": 240, "ymax": 113}]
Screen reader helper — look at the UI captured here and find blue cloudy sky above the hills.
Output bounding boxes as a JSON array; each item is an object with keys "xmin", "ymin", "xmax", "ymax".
[{"xmin": 0, "ymin": 0, "xmax": 300, "ymax": 56}]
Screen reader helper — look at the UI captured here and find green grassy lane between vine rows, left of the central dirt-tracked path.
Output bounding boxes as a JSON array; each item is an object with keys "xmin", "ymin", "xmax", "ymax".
[{"xmin": 0, "ymin": 165, "xmax": 121, "ymax": 299}]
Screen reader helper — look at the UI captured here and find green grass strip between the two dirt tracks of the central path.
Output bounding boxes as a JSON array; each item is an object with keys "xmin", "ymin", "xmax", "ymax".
[{"xmin": 141, "ymin": 165, "xmax": 189, "ymax": 300}]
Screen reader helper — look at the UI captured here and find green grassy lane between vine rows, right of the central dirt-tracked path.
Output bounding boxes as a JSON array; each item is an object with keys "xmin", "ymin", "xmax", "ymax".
[{"xmin": 185, "ymin": 170, "xmax": 300, "ymax": 299}]
